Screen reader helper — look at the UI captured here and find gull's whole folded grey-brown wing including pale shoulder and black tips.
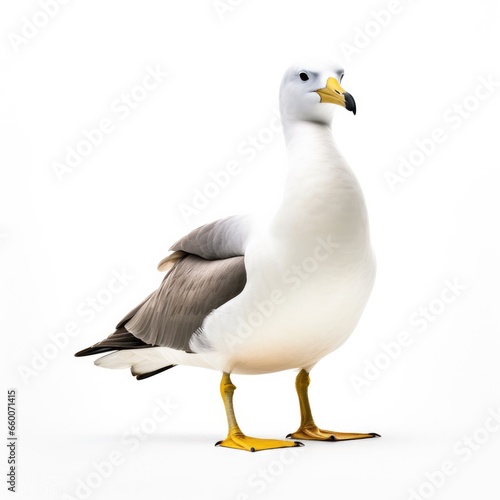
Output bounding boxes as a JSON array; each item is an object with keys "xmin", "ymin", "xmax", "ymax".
[{"xmin": 76, "ymin": 216, "xmax": 250, "ymax": 356}]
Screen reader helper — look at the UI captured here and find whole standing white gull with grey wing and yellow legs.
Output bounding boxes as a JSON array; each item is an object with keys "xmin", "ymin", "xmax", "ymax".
[{"xmin": 75, "ymin": 62, "xmax": 379, "ymax": 452}]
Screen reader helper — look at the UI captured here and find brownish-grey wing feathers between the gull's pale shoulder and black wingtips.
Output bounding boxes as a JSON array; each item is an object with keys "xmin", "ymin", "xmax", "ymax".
[{"xmin": 125, "ymin": 254, "xmax": 246, "ymax": 351}]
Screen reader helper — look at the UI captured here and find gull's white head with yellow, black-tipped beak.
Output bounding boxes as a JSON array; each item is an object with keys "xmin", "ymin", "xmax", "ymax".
[{"xmin": 280, "ymin": 63, "xmax": 356, "ymax": 124}]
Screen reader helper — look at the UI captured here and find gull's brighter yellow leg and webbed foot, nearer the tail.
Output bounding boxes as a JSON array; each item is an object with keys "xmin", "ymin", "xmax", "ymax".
[{"xmin": 215, "ymin": 373, "xmax": 304, "ymax": 451}]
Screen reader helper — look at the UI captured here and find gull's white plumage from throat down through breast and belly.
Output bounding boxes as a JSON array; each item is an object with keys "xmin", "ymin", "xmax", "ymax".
[{"xmin": 193, "ymin": 120, "xmax": 375, "ymax": 373}]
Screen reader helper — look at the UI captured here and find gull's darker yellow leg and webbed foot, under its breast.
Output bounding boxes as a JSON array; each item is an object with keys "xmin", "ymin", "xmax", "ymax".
[{"xmin": 287, "ymin": 370, "xmax": 380, "ymax": 441}]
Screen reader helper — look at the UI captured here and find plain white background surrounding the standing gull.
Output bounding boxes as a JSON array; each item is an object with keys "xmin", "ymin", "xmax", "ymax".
[{"xmin": 0, "ymin": 0, "xmax": 500, "ymax": 500}]
